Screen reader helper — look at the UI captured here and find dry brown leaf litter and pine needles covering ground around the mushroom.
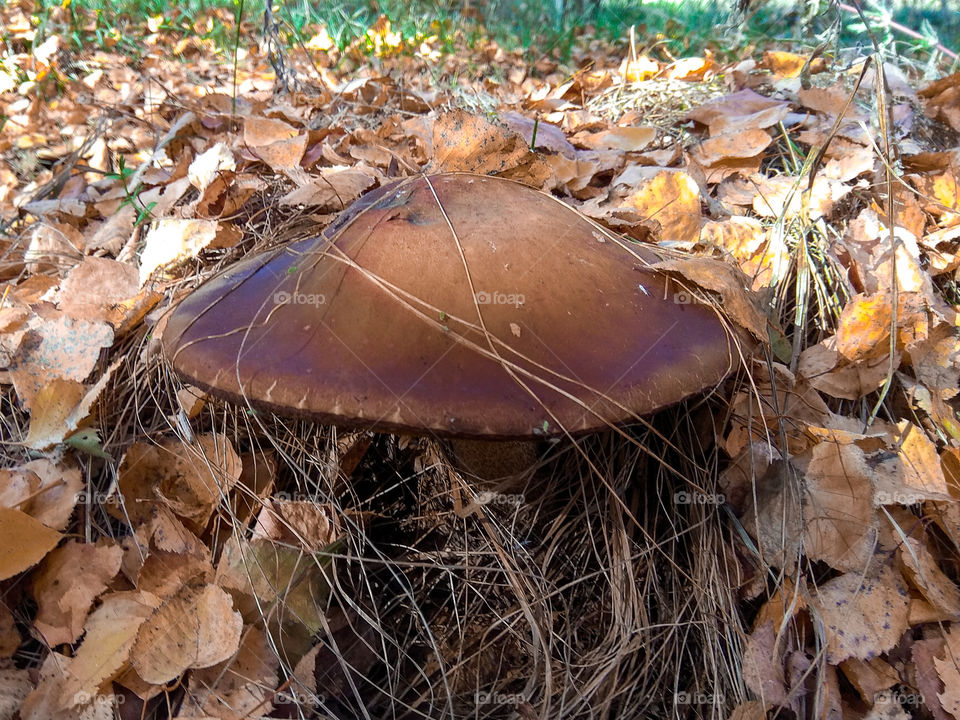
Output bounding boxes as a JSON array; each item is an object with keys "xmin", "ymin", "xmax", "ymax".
[{"xmin": 0, "ymin": 6, "xmax": 960, "ymax": 720}]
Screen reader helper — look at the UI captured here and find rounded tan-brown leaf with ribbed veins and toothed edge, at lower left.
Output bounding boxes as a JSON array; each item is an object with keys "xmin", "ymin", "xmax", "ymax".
[{"xmin": 130, "ymin": 585, "xmax": 243, "ymax": 685}]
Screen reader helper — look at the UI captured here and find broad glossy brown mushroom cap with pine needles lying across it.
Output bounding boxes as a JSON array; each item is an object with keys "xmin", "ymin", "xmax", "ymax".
[{"xmin": 163, "ymin": 173, "xmax": 737, "ymax": 438}]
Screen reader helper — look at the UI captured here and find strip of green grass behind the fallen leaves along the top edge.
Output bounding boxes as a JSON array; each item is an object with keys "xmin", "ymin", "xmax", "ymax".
[{"xmin": 8, "ymin": 0, "xmax": 960, "ymax": 68}]
